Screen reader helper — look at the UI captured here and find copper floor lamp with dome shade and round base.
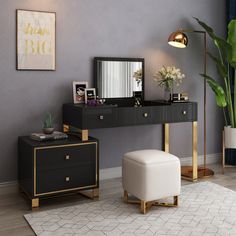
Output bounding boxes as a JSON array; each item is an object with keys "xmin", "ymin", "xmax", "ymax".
[{"xmin": 168, "ymin": 29, "xmax": 214, "ymax": 178}]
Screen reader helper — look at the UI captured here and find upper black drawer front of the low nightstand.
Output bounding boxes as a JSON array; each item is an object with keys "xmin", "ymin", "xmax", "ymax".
[{"xmin": 36, "ymin": 143, "xmax": 97, "ymax": 171}]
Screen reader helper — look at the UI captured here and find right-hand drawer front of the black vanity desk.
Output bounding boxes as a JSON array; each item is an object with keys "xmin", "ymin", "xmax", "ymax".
[{"xmin": 167, "ymin": 103, "xmax": 193, "ymax": 122}]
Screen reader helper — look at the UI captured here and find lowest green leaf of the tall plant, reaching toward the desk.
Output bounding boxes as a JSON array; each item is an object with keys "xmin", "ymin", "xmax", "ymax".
[{"xmin": 200, "ymin": 74, "xmax": 227, "ymax": 108}]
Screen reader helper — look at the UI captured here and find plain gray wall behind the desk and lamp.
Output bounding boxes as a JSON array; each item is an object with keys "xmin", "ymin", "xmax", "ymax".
[{"xmin": 0, "ymin": 0, "xmax": 225, "ymax": 182}]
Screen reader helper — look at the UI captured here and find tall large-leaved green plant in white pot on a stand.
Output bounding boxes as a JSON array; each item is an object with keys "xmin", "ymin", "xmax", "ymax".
[{"xmin": 195, "ymin": 18, "xmax": 236, "ymax": 165}]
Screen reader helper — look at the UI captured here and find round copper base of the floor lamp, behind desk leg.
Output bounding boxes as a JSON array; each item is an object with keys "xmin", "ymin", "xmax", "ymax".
[{"xmin": 181, "ymin": 166, "xmax": 214, "ymax": 179}]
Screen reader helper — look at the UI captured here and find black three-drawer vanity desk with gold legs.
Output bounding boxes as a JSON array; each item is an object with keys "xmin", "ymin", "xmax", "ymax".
[{"xmin": 63, "ymin": 101, "xmax": 198, "ymax": 181}]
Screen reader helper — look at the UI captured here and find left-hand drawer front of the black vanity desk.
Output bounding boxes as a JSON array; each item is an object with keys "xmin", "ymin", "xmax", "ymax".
[{"xmin": 83, "ymin": 108, "xmax": 117, "ymax": 129}]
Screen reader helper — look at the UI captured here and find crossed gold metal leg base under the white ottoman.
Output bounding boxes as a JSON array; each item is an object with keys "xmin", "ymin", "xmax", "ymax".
[{"xmin": 124, "ymin": 190, "xmax": 179, "ymax": 214}]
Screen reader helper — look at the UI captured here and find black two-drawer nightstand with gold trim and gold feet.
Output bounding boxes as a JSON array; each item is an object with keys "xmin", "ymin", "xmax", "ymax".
[{"xmin": 18, "ymin": 136, "xmax": 99, "ymax": 208}]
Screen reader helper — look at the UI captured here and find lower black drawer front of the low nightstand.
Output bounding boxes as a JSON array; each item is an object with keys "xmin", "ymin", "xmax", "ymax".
[{"xmin": 35, "ymin": 163, "xmax": 97, "ymax": 196}]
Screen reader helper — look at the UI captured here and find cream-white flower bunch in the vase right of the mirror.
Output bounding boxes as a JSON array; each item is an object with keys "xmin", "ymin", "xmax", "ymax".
[{"xmin": 154, "ymin": 66, "xmax": 185, "ymax": 92}]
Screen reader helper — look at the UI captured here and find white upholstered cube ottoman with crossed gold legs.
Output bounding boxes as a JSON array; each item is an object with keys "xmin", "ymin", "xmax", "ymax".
[{"xmin": 122, "ymin": 150, "xmax": 181, "ymax": 214}]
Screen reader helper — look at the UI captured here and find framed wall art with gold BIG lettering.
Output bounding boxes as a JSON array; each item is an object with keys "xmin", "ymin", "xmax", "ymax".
[{"xmin": 16, "ymin": 10, "xmax": 56, "ymax": 71}]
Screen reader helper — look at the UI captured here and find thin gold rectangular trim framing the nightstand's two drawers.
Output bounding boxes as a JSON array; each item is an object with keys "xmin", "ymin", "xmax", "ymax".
[{"xmin": 34, "ymin": 142, "xmax": 98, "ymax": 196}]
